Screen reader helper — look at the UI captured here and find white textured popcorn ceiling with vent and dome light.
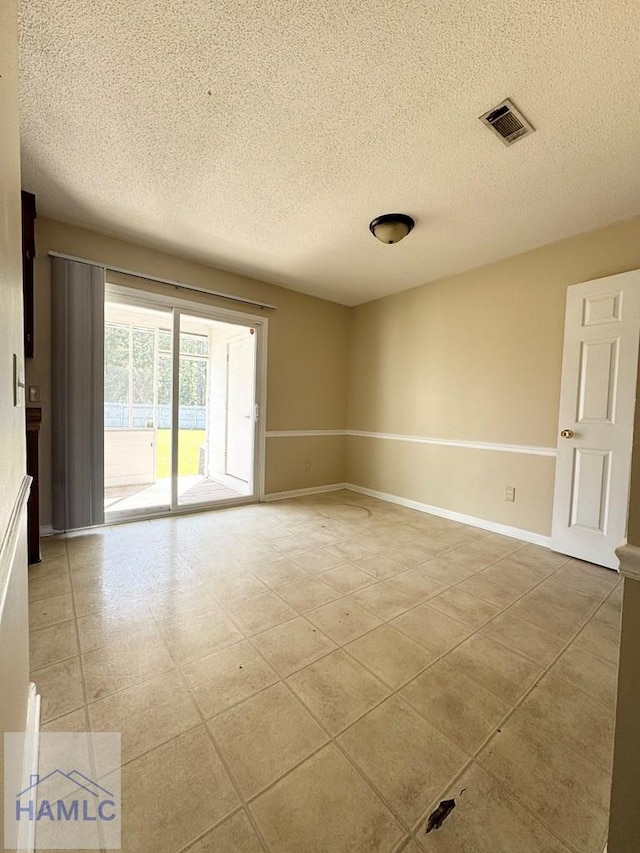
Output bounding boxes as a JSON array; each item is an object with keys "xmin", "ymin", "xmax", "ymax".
[{"xmin": 21, "ymin": 0, "xmax": 640, "ymax": 304}]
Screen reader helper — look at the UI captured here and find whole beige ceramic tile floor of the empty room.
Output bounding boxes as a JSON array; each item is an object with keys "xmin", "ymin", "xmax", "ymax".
[{"xmin": 30, "ymin": 492, "xmax": 621, "ymax": 853}]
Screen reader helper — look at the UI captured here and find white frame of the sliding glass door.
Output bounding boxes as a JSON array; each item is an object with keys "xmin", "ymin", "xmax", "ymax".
[{"xmin": 105, "ymin": 282, "xmax": 269, "ymax": 523}]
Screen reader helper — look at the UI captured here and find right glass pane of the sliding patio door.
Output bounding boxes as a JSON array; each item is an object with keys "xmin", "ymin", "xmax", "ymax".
[{"xmin": 178, "ymin": 314, "xmax": 256, "ymax": 505}]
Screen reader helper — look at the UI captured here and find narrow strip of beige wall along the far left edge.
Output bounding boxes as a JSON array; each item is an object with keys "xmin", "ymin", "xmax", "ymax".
[{"xmin": 0, "ymin": 0, "xmax": 29, "ymax": 837}]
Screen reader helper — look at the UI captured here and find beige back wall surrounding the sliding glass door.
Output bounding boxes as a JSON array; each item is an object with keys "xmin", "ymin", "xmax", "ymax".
[{"xmin": 27, "ymin": 217, "xmax": 349, "ymax": 525}]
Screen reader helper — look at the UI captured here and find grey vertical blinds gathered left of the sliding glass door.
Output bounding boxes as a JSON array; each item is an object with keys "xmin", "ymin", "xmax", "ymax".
[{"xmin": 51, "ymin": 257, "xmax": 105, "ymax": 530}]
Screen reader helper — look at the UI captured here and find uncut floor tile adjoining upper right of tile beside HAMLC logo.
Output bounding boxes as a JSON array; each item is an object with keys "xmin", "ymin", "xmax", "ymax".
[{"xmin": 208, "ymin": 684, "xmax": 327, "ymax": 797}]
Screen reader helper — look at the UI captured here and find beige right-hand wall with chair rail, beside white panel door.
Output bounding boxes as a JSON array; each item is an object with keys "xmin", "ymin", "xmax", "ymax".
[{"xmin": 347, "ymin": 219, "xmax": 640, "ymax": 535}]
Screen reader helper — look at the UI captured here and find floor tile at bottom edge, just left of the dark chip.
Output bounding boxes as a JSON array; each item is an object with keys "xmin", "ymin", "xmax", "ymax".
[{"xmin": 251, "ymin": 744, "xmax": 403, "ymax": 853}]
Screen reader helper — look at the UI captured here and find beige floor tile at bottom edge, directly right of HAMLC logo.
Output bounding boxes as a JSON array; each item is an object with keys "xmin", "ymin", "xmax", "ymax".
[{"xmin": 107, "ymin": 726, "xmax": 240, "ymax": 853}]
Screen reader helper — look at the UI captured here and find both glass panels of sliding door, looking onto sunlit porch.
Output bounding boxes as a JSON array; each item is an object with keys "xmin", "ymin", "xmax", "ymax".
[{"xmin": 104, "ymin": 287, "xmax": 261, "ymax": 521}]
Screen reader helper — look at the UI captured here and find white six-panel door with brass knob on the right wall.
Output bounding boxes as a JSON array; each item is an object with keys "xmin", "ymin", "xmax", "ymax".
[{"xmin": 551, "ymin": 270, "xmax": 640, "ymax": 569}]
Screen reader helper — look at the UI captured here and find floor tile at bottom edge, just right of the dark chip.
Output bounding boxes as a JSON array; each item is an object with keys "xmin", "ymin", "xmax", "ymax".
[{"xmin": 423, "ymin": 764, "xmax": 569, "ymax": 853}]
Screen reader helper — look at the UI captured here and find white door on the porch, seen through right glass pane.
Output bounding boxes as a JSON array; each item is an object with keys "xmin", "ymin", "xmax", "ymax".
[{"xmin": 227, "ymin": 336, "xmax": 255, "ymax": 483}]
